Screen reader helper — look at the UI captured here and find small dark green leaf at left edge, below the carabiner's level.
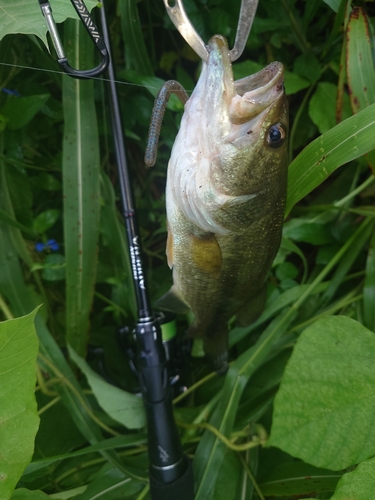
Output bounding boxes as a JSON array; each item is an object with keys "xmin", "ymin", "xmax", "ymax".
[{"xmin": 0, "ymin": 94, "xmax": 50, "ymax": 130}]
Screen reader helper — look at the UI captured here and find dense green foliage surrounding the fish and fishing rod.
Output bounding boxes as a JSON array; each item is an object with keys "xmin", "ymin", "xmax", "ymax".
[{"xmin": 0, "ymin": 0, "xmax": 375, "ymax": 500}]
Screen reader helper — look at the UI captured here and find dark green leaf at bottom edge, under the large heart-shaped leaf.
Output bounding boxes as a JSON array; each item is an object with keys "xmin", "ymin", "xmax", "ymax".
[{"xmin": 259, "ymin": 462, "xmax": 342, "ymax": 497}]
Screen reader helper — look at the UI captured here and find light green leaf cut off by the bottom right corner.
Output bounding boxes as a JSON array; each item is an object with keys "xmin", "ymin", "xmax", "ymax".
[{"xmin": 331, "ymin": 458, "xmax": 375, "ymax": 500}]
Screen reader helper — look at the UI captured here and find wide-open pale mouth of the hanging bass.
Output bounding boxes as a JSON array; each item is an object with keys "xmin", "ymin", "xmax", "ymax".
[{"xmin": 208, "ymin": 35, "xmax": 284, "ymax": 125}]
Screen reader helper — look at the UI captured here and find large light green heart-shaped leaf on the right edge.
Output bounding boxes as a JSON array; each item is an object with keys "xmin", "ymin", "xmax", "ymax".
[{"xmin": 268, "ymin": 316, "xmax": 375, "ymax": 470}]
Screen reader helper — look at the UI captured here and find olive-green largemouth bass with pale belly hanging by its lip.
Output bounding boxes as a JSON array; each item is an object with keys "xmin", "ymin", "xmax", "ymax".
[{"xmin": 159, "ymin": 35, "xmax": 288, "ymax": 372}]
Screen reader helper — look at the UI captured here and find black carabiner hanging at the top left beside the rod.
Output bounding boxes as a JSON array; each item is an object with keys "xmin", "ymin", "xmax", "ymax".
[{"xmin": 39, "ymin": 0, "xmax": 109, "ymax": 79}]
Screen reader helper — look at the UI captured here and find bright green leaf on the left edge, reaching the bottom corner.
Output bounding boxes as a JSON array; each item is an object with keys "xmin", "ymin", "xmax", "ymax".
[{"xmin": 0, "ymin": 310, "xmax": 39, "ymax": 500}]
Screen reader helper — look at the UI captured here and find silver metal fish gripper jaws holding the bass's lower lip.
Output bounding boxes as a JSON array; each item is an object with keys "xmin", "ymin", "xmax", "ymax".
[{"xmin": 164, "ymin": 0, "xmax": 258, "ymax": 62}]
